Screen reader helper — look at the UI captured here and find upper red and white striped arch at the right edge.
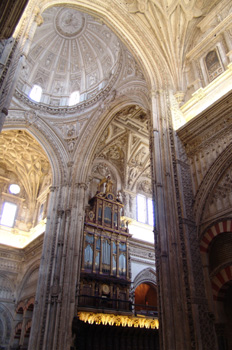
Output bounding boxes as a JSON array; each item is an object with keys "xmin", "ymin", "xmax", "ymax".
[{"xmin": 200, "ymin": 219, "xmax": 232, "ymax": 252}]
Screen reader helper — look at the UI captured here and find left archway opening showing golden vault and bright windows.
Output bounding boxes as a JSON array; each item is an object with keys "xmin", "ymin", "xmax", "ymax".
[{"xmin": 0, "ymin": 130, "xmax": 52, "ymax": 248}]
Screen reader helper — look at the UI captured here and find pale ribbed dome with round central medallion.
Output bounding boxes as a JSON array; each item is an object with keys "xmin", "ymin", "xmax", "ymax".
[{"xmin": 18, "ymin": 7, "xmax": 120, "ymax": 106}]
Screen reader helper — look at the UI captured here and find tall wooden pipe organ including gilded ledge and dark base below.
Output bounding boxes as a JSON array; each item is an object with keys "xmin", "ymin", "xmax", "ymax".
[{"xmin": 71, "ymin": 177, "xmax": 159, "ymax": 350}]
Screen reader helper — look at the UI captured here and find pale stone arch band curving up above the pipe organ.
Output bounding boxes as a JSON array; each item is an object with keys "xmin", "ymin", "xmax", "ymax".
[{"xmin": 73, "ymin": 97, "xmax": 150, "ymax": 183}]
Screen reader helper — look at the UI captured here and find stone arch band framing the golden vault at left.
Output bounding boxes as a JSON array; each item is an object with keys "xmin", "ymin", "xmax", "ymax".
[{"xmin": 3, "ymin": 116, "xmax": 68, "ymax": 185}]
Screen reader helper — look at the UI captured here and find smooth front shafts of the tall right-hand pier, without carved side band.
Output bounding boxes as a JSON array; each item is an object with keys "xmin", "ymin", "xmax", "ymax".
[{"xmin": 151, "ymin": 91, "xmax": 192, "ymax": 350}]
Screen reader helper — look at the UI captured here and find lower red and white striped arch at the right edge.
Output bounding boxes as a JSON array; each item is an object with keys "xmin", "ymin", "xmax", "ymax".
[{"xmin": 211, "ymin": 266, "xmax": 232, "ymax": 301}]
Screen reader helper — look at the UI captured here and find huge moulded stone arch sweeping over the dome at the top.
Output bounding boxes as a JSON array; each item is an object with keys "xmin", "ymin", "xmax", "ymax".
[{"xmin": 24, "ymin": 0, "xmax": 163, "ymax": 89}]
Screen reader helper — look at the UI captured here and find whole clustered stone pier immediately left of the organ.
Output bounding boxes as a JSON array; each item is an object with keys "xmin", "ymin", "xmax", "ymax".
[{"xmin": 28, "ymin": 180, "xmax": 86, "ymax": 350}]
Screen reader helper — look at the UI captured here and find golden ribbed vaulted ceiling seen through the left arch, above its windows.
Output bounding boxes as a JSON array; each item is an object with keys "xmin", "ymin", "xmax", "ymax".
[{"xmin": 0, "ymin": 130, "xmax": 51, "ymax": 205}]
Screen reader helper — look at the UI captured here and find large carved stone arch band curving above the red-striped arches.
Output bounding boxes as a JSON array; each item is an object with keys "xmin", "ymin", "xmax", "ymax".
[{"xmin": 194, "ymin": 143, "xmax": 232, "ymax": 228}]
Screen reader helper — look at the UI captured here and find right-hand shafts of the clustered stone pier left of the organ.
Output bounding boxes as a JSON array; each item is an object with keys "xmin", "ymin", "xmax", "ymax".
[{"xmin": 54, "ymin": 183, "xmax": 87, "ymax": 350}]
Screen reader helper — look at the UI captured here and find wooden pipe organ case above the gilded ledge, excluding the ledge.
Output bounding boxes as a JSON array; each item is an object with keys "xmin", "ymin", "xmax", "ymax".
[{"xmin": 78, "ymin": 177, "xmax": 131, "ymax": 312}]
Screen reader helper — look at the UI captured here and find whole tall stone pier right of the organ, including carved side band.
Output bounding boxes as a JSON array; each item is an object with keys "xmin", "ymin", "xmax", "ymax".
[{"xmin": 151, "ymin": 91, "xmax": 216, "ymax": 350}]
